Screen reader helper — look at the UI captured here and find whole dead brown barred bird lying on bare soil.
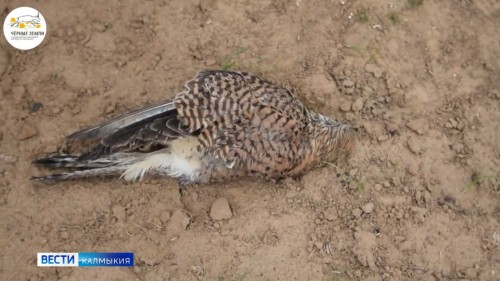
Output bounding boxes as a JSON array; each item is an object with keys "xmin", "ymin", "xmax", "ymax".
[{"xmin": 34, "ymin": 70, "xmax": 354, "ymax": 184}]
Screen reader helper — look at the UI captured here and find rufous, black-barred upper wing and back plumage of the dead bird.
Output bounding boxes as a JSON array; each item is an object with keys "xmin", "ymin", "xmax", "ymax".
[{"xmin": 174, "ymin": 70, "xmax": 308, "ymax": 173}]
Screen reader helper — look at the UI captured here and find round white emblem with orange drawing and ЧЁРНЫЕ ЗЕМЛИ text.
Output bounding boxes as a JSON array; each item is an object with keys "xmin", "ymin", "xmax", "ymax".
[{"xmin": 3, "ymin": 7, "xmax": 47, "ymax": 50}]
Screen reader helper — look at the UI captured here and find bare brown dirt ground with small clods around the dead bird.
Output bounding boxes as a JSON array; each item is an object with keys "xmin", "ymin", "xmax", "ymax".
[{"xmin": 0, "ymin": 0, "xmax": 500, "ymax": 280}]
